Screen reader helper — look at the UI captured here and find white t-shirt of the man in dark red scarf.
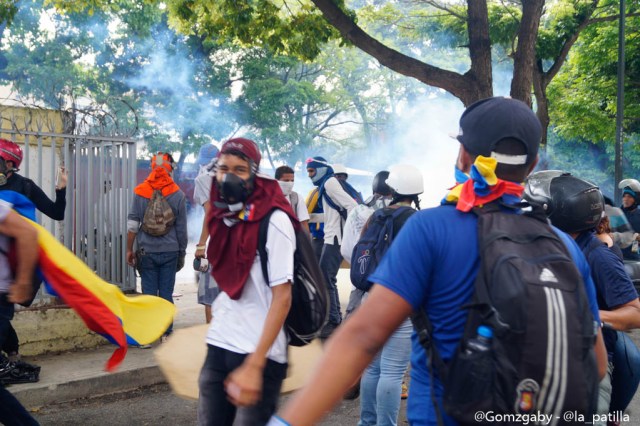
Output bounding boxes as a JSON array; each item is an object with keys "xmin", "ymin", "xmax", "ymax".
[{"xmin": 207, "ymin": 210, "xmax": 296, "ymax": 363}]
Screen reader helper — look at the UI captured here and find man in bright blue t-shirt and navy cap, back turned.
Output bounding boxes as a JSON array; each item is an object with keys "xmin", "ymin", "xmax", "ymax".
[{"xmin": 270, "ymin": 97, "xmax": 606, "ymax": 426}]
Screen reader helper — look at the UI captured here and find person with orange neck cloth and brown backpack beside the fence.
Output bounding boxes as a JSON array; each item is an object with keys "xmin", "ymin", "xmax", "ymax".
[{"xmin": 127, "ymin": 152, "xmax": 187, "ymax": 349}]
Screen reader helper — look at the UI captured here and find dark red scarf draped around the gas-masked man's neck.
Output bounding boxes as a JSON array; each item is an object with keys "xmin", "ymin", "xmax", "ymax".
[{"xmin": 207, "ymin": 176, "xmax": 300, "ymax": 300}]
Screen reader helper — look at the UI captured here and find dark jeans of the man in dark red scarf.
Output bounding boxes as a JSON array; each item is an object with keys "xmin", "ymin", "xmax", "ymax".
[{"xmin": 198, "ymin": 345, "xmax": 287, "ymax": 426}]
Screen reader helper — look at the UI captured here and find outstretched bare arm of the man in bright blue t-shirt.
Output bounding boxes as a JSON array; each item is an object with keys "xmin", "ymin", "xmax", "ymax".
[{"xmin": 279, "ymin": 285, "xmax": 411, "ymax": 426}]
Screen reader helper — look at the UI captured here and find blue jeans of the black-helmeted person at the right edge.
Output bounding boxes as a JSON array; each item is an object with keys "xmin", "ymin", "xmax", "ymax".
[{"xmin": 609, "ymin": 331, "xmax": 640, "ymax": 413}]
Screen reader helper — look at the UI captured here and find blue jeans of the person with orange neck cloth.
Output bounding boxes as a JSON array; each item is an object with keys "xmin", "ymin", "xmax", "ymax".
[{"xmin": 139, "ymin": 251, "xmax": 178, "ymax": 334}]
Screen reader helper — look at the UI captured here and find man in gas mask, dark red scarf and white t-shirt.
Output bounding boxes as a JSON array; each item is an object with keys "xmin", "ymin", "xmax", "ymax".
[{"xmin": 198, "ymin": 138, "xmax": 300, "ymax": 425}]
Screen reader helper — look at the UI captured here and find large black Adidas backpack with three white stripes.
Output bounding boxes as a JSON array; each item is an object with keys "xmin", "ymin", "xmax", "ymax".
[{"xmin": 412, "ymin": 204, "xmax": 598, "ymax": 424}]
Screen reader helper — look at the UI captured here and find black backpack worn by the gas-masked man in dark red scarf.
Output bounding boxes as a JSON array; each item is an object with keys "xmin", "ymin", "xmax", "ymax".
[{"xmin": 258, "ymin": 210, "xmax": 329, "ymax": 346}]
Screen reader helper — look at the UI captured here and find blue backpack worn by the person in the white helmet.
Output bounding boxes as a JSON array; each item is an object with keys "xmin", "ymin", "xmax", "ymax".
[{"xmin": 351, "ymin": 206, "xmax": 415, "ymax": 291}]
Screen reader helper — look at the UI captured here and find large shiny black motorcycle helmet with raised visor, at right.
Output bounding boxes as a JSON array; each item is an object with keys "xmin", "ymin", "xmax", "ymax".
[{"xmin": 524, "ymin": 170, "xmax": 604, "ymax": 233}]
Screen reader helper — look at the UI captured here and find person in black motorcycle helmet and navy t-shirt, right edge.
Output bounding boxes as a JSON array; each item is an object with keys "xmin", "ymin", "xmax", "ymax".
[{"xmin": 524, "ymin": 170, "xmax": 640, "ymax": 424}]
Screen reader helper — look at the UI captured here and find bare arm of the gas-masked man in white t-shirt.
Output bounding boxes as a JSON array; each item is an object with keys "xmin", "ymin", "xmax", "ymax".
[{"xmin": 225, "ymin": 282, "xmax": 291, "ymax": 406}]
